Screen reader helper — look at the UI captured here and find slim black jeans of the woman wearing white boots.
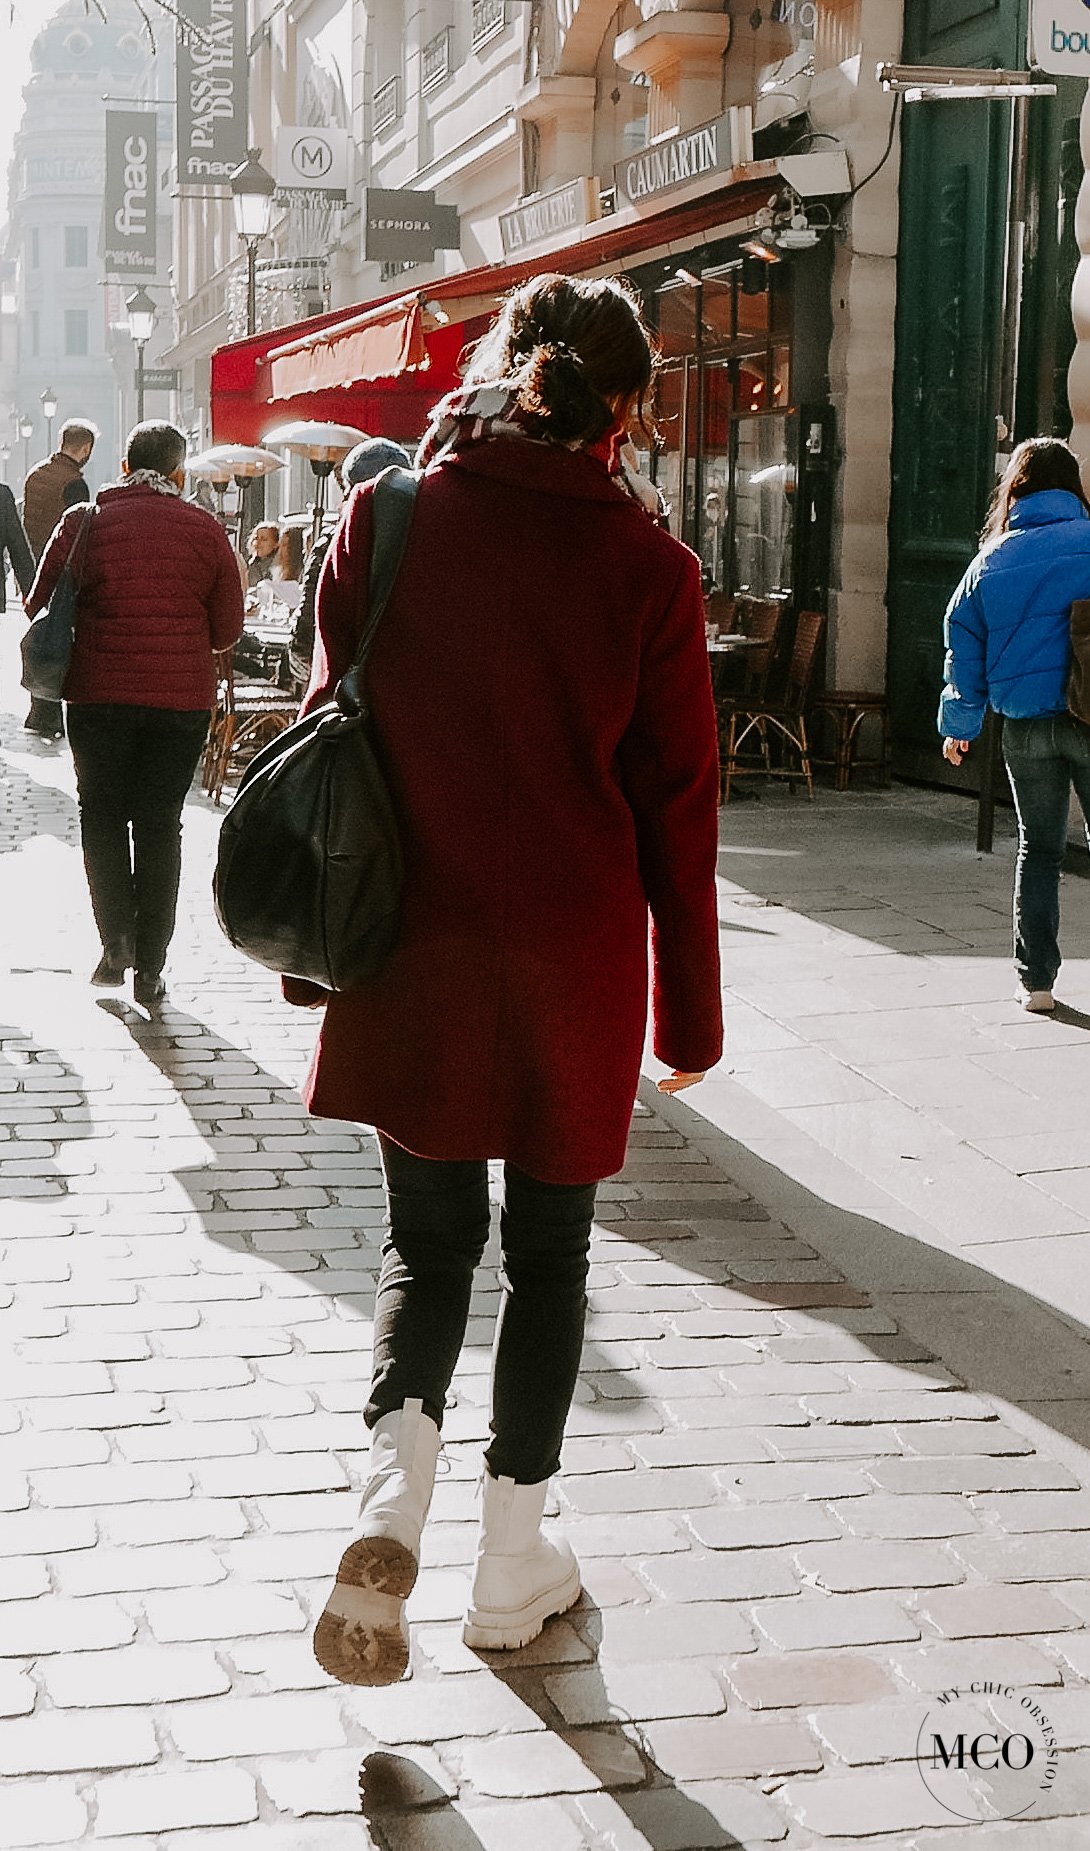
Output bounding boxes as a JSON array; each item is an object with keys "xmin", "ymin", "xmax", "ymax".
[{"xmin": 365, "ymin": 1133, "xmax": 596, "ymax": 1485}]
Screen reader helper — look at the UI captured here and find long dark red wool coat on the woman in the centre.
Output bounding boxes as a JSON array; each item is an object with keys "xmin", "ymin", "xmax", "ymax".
[{"xmin": 297, "ymin": 439, "xmax": 722, "ymax": 1183}]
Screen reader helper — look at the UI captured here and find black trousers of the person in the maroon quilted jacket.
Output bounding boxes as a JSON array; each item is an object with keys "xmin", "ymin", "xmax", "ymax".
[{"xmin": 68, "ymin": 703, "xmax": 209, "ymax": 977}]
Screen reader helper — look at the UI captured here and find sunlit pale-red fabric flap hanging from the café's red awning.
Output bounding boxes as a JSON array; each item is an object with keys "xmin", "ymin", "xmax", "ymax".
[{"xmin": 265, "ymin": 294, "xmax": 431, "ymax": 400}]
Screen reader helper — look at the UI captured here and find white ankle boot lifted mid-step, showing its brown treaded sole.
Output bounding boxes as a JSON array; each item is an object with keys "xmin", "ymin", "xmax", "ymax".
[{"xmin": 315, "ymin": 1401, "xmax": 439, "ymax": 1684}]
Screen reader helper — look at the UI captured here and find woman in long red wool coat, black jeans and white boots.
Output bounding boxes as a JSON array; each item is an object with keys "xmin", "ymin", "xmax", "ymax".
[{"xmin": 299, "ymin": 276, "xmax": 722, "ymax": 1683}]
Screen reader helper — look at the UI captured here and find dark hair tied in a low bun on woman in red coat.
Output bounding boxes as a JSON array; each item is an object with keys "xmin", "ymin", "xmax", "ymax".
[{"xmin": 466, "ymin": 276, "xmax": 657, "ymax": 444}]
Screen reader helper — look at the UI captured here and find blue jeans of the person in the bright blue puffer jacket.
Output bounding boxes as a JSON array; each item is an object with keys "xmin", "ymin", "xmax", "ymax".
[{"xmin": 1003, "ymin": 713, "xmax": 1090, "ymax": 990}]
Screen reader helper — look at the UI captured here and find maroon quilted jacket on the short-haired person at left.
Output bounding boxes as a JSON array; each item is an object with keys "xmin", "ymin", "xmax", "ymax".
[{"xmin": 26, "ymin": 483, "xmax": 242, "ymax": 713}]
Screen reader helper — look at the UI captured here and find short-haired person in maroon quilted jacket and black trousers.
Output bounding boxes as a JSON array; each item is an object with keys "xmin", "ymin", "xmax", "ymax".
[{"xmin": 26, "ymin": 422, "xmax": 242, "ymax": 1009}]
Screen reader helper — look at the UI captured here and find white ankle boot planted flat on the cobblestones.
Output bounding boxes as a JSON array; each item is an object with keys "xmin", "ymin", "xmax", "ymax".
[{"xmin": 463, "ymin": 1472, "xmax": 581, "ymax": 1651}]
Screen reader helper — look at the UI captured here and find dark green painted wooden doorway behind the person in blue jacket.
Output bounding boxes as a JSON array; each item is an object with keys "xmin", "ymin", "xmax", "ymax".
[{"xmin": 888, "ymin": 0, "xmax": 1083, "ymax": 785}]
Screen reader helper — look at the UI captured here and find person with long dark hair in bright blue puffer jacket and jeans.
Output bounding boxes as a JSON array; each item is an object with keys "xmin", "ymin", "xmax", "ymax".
[{"xmin": 938, "ymin": 437, "xmax": 1090, "ymax": 1014}]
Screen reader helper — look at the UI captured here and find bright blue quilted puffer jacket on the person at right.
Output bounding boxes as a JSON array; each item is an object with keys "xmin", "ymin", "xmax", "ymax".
[{"xmin": 938, "ymin": 489, "xmax": 1090, "ymax": 739}]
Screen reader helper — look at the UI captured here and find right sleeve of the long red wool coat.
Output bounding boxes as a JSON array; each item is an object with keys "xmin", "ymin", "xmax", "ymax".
[{"xmin": 620, "ymin": 555, "xmax": 724, "ymax": 1074}]
